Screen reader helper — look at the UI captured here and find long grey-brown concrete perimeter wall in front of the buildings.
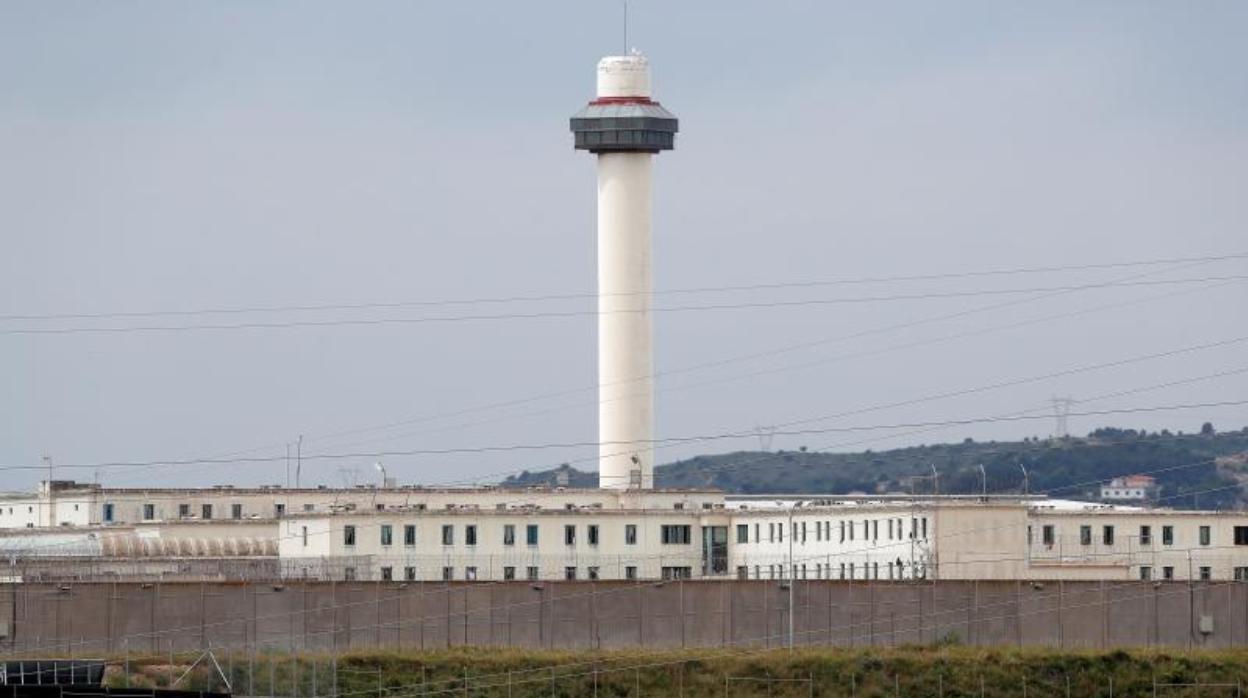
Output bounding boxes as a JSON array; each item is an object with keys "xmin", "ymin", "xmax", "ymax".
[{"xmin": 0, "ymin": 581, "xmax": 1248, "ymax": 657}]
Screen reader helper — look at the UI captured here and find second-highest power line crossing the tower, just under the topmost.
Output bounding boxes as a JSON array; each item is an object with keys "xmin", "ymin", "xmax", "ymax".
[{"xmin": 0, "ymin": 275, "xmax": 1248, "ymax": 335}]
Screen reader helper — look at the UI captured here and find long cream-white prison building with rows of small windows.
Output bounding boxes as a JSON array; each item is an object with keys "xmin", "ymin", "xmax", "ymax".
[{"xmin": 7, "ymin": 482, "xmax": 1248, "ymax": 581}]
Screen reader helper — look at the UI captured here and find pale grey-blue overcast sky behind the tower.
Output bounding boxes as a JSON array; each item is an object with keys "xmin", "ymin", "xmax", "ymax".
[{"xmin": 0, "ymin": 0, "xmax": 1248, "ymax": 489}]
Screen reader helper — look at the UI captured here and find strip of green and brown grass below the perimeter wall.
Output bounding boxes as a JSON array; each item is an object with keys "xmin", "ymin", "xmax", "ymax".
[{"xmin": 107, "ymin": 646, "xmax": 1248, "ymax": 698}]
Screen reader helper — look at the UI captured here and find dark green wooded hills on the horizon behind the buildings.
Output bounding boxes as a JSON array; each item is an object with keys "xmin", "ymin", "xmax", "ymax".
[{"xmin": 502, "ymin": 425, "xmax": 1248, "ymax": 509}]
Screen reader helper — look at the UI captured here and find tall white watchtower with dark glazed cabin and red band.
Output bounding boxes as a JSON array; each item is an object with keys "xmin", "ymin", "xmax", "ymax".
[{"xmin": 572, "ymin": 55, "xmax": 676, "ymax": 489}]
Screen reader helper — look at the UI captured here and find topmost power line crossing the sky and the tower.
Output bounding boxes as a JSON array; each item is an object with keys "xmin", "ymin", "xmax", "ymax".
[{"xmin": 0, "ymin": 252, "xmax": 1248, "ymax": 321}]
